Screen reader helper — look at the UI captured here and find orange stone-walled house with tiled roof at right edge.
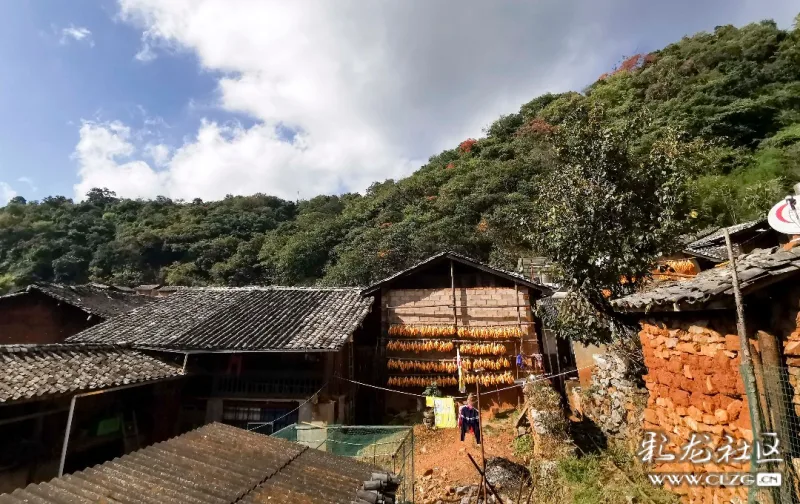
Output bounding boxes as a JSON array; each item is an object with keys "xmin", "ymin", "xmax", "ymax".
[{"xmin": 612, "ymin": 246, "xmax": 800, "ymax": 502}]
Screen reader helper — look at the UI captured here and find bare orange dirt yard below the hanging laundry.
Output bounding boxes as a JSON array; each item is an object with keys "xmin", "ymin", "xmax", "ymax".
[{"xmin": 414, "ymin": 405, "xmax": 524, "ymax": 504}]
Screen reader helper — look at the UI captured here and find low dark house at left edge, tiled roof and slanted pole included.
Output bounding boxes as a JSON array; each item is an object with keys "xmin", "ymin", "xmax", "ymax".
[{"xmin": 0, "ymin": 344, "xmax": 183, "ymax": 493}]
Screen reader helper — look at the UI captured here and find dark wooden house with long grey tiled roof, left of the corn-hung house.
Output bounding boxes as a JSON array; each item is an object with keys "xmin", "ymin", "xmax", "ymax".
[{"xmin": 68, "ymin": 287, "xmax": 372, "ymax": 433}]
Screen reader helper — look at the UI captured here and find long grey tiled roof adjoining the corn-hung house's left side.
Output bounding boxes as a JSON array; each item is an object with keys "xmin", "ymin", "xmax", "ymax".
[{"xmin": 67, "ymin": 287, "xmax": 372, "ymax": 351}]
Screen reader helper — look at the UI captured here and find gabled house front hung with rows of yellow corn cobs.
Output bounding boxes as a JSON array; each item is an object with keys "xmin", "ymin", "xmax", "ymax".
[{"xmin": 363, "ymin": 252, "xmax": 556, "ymax": 413}]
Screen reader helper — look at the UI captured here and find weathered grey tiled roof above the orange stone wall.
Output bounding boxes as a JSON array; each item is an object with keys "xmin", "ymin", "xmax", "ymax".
[{"xmin": 612, "ymin": 247, "xmax": 800, "ymax": 312}]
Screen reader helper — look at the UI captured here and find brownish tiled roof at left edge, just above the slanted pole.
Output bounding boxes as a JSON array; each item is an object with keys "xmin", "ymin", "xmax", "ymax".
[{"xmin": 0, "ymin": 344, "xmax": 181, "ymax": 403}]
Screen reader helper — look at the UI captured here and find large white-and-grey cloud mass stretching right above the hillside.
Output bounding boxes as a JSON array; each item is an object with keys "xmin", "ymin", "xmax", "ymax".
[{"xmin": 76, "ymin": 0, "xmax": 787, "ymax": 199}]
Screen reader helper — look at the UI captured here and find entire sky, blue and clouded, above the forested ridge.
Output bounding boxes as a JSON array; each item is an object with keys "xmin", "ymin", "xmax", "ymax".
[{"xmin": 0, "ymin": 0, "xmax": 800, "ymax": 204}]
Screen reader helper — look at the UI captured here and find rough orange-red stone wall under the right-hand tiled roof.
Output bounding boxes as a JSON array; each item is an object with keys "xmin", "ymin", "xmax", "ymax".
[{"xmin": 639, "ymin": 318, "xmax": 753, "ymax": 502}]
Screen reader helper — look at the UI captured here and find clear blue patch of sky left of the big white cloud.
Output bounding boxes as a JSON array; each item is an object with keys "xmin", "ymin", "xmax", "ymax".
[{"xmin": 0, "ymin": 0, "xmax": 230, "ymax": 199}]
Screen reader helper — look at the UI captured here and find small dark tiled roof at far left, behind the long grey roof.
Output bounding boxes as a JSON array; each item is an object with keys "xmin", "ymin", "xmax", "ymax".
[{"xmin": 17, "ymin": 283, "xmax": 158, "ymax": 319}]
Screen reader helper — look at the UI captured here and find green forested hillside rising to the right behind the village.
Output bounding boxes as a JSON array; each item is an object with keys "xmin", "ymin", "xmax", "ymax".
[{"xmin": 0, "ymin": 17, "xmax": 800, "ymax": 291}]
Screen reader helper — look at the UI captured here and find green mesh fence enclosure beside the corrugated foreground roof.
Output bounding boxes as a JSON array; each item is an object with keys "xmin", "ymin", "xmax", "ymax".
[{"xmin": 272, "ymin": 424, "xmax": 414, "ymax": 503}]
